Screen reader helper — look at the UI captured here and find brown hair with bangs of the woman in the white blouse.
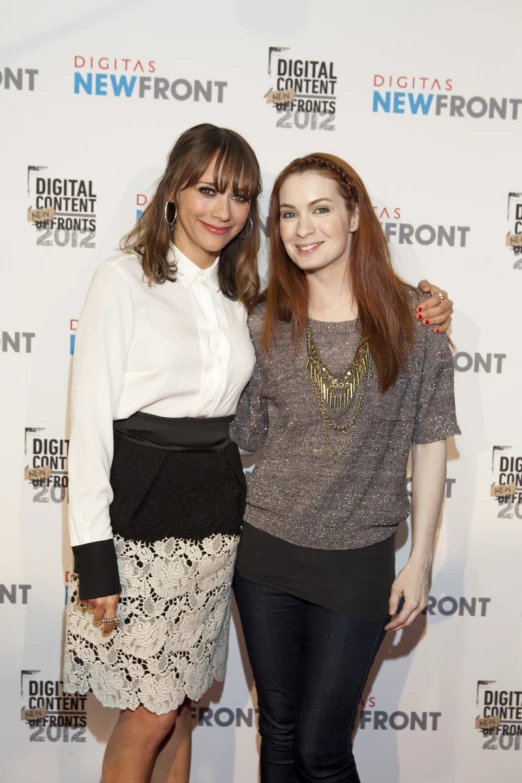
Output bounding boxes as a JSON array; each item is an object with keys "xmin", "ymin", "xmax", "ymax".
[{"xmin": 120, "ymin": 123, "xmax": 262, "ymax": 310}]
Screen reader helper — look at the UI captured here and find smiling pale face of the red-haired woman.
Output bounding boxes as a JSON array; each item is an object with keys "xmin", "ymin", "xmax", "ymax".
[{"xmin": 279, "ymin": 171, "xmax": 358, "ymax": 273}]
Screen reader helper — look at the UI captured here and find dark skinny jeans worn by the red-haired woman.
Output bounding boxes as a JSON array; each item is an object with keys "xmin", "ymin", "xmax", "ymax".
[{"xmin": 234, "ymin": 571, "xmax": 386, "ymax": 783}]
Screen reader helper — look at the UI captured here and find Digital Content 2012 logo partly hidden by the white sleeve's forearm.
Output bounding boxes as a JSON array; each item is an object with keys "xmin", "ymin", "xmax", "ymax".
[{"xmin": 24, "ymin": 427, "xmax": 69, "ymax": 503}]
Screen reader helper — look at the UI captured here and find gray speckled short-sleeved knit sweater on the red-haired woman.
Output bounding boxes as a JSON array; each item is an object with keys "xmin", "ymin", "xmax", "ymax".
[{"xmin": 231, "ymin": 296, "xmax": 460, "ymax": 549}]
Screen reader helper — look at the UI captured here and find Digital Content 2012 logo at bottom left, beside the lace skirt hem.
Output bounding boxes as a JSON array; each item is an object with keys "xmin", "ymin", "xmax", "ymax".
[{"xmin": 20, "ymin": 669, "xmax": 87, "ymax": 742}]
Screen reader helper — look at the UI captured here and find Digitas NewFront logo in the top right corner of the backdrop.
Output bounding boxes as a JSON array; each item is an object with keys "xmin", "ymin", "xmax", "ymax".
[{"xmin": 372, "ymin": 73, "xmax": 522, "ymax": 120}]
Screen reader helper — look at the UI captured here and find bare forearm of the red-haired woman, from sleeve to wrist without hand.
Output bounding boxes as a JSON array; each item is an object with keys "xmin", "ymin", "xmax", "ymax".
[{"xmin": 410, "ymin": 440, "xmax": 447, "ymax": 567}]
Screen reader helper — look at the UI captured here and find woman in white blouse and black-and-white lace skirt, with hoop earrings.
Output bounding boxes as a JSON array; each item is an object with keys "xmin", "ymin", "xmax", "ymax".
[{"xmin": 64, "ymin": 125, "xmax": 261, "ymax": 783}]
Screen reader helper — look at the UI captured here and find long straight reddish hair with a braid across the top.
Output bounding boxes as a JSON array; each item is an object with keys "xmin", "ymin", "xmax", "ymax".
[{"xmin": 262, "ymin": 152, "xmax": 415, "ymax": 392}]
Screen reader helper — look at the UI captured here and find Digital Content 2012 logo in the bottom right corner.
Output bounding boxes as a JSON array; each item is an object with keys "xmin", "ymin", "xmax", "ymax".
[{"xmin": 475, "ymin": 680, "xmax": 522, "ymax": 750}]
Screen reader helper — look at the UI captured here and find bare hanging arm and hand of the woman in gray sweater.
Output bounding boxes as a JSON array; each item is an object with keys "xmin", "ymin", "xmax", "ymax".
[{"xmin": 386, "ymin": 440, "xmax": 447, "ymax": 631}]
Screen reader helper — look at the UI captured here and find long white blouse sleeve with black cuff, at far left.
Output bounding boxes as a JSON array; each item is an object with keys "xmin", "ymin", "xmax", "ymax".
[{"xmin": 69, "ymin": 262, "xmax": 134, "ymax": 600}]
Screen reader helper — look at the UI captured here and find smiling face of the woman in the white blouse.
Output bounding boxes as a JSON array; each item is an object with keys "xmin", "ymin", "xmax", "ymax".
[{"xmin": 172, "ymin": 162, "xmax": 250, "ymax": 265}]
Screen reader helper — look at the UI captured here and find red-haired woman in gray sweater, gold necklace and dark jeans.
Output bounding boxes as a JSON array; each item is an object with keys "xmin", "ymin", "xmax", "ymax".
[{"xmin": 233, "ymin": 153, "xmax": 459, "ymax": 783}]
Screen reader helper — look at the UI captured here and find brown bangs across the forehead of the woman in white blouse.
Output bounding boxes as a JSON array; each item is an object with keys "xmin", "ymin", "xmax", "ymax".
[{"xmin": 181, "ymin": 133, "xmax": 262, "ymax": 201}]
